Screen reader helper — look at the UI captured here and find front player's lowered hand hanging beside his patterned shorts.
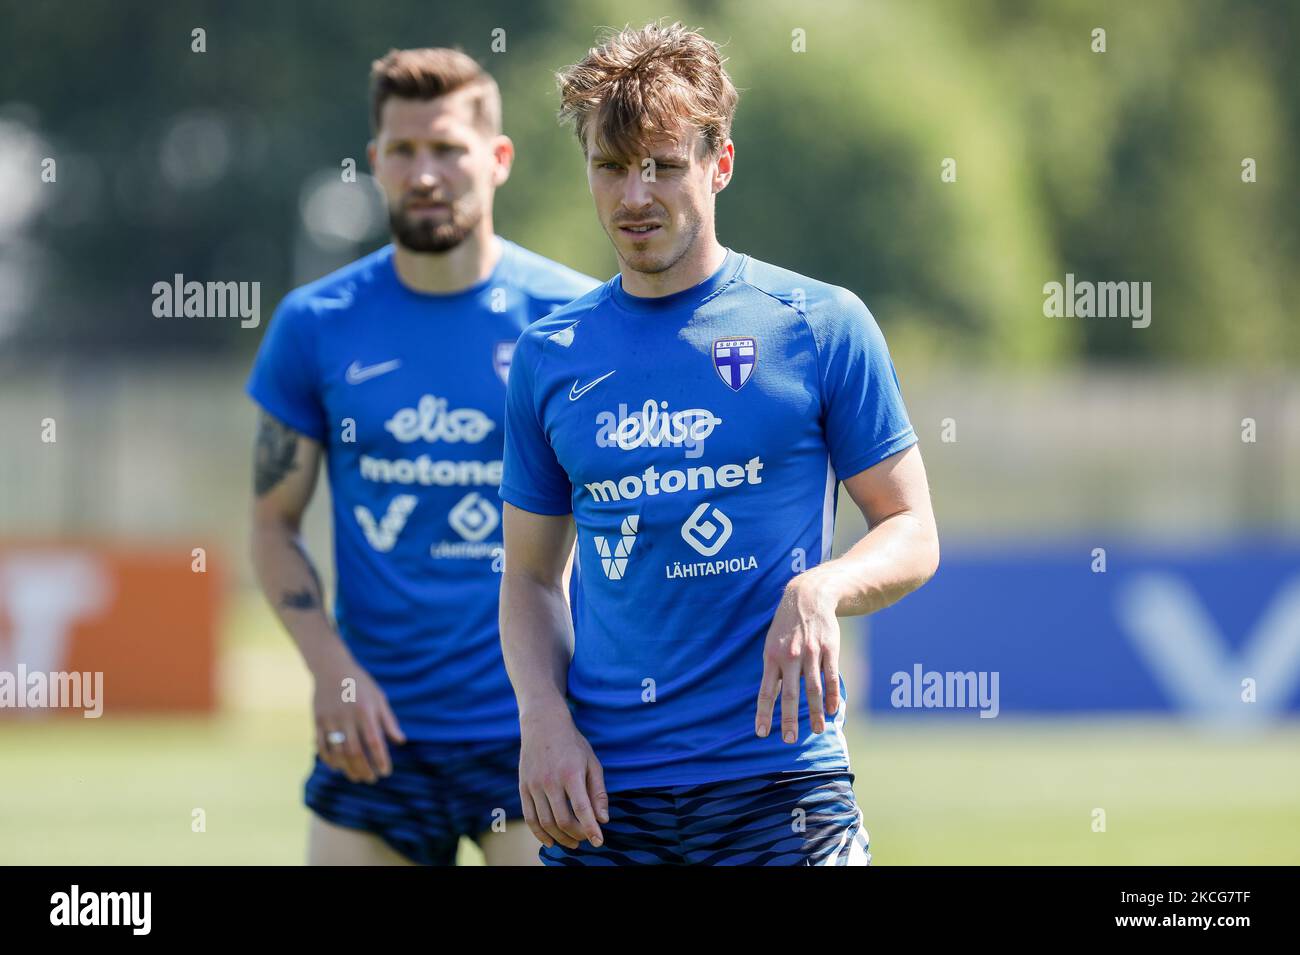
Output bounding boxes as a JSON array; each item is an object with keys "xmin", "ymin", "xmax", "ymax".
[{"xmin": 519, "ymin": 707, "xmax": 610, "ymax": 848}]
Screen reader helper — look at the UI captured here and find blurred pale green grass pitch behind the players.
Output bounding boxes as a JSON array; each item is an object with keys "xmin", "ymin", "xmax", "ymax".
[{"xmin": 0, "ymin": 589, "xmax": 1300, "ymax": 865}]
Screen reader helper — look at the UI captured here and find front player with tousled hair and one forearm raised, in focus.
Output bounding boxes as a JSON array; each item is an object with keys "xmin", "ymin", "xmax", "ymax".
[{"xmin": 501, "ymin": 25, "xmax": 939, "ymax": 865}]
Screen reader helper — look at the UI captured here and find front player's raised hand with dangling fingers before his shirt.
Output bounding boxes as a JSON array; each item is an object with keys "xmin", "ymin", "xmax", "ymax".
[{"xmin": 754, "ymin": 578, "xmax": 840, "ymax": 743}]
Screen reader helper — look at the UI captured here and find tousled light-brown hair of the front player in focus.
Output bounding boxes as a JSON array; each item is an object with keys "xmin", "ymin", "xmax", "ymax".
[{"xmin": 556, "ymin": 23, "xmax": 740, "ymax": 157}]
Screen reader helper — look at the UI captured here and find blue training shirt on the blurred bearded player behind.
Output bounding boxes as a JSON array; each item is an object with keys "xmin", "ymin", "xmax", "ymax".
[{"xmin": 247, "ymin": 239, "xmax": 598, "ymax": 742}]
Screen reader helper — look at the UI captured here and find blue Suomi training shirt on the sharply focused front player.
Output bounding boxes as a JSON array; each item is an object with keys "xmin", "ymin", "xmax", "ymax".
[{"xmin": 501, "ymin": 251, "xmax": 917, "ymax": 791}]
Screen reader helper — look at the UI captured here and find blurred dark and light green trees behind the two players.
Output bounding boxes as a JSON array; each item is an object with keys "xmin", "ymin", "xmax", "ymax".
[{"xmin": 0, "ymin": 0, "xmax": 1300, "ymax": 370}]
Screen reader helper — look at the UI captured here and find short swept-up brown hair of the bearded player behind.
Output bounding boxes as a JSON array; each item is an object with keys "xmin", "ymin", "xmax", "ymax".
[{"xmin": 371, "ymin": 47, "xmax": 501, "ymax": 135}]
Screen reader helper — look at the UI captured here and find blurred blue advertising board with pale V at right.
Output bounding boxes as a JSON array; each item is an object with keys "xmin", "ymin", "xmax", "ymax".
[{"xmin": 865, "ymin": 541, "xmax": 1300, "ymax": 726}]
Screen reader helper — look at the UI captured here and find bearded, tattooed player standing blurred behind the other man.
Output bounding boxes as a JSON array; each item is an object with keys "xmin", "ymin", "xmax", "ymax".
[{"xmin": 248, "ymin": 49, "xmax": 597, "ymax": 865}]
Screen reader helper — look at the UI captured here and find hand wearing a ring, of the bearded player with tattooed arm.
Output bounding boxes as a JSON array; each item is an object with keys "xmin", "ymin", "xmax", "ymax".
[{"xmin": 313, "ymin": 663, "xmax": 406, "ymax": 782}]
